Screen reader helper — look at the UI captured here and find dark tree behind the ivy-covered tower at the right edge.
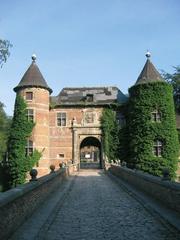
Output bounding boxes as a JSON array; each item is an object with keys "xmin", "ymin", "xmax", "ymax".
[{"xmin": 162, "ymin": 66, "xmax": 180, "ymax": 113}]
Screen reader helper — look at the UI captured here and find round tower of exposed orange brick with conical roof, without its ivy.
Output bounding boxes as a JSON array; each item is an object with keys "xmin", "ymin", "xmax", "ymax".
[{"xmin": 14, "ymin": 54, "xmax": 52, "ymax": 176}]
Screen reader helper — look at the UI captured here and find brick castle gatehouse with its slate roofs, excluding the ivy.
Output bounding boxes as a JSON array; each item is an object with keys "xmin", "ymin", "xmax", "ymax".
[{"xmin": 14, "ymin": 56, "xmax": 179, "ymax": 176}]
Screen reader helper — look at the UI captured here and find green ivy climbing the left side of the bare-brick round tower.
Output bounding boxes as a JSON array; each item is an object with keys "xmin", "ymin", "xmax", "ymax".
[{"xmin": 4, "ymin": 95, "xmax": 40, "ymax": 189}]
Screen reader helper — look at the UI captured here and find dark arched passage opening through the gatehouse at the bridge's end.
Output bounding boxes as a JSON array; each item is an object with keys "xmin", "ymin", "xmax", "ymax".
[{"xmin": 80, "ymin": 137, "xmax": 102, "ymax": 168}]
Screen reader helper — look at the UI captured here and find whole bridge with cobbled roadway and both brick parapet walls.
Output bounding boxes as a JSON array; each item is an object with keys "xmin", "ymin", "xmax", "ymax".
[{"xmin": 0, "ymin": 165, "xmax": 180, "ymax": 240}]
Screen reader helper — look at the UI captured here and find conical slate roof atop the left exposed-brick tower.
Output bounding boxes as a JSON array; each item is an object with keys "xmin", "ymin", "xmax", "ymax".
[{"xmin": 14, "ymin": 58, "xmax": 52, "ymax": 93}]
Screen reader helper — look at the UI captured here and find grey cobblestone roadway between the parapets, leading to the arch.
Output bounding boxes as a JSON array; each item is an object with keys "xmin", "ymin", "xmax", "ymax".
[{"xmin": 11, "ymin": 170, "xmax": 180, "ymax": 240}]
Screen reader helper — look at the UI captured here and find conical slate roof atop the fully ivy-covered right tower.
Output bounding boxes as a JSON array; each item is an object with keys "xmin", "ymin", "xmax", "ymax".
[{"xmin": 135, "ymin": 58, "xmax": 164, "ymax": 85}]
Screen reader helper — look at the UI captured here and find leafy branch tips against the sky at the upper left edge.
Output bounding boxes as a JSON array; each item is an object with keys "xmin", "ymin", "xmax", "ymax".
[{"xmin": 0, "ymin": 39, "xmax": 12, "ymax": 67}]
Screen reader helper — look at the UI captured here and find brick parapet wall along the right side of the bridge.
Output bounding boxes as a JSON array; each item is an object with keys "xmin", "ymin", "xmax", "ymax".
[{"xmin": 107, "ymin": 164, "xmax": 180, "ymax": 213}]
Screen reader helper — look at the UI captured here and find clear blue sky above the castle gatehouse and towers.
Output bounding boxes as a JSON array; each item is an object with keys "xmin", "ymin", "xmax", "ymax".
[{"xmin": 0, "ymin": 0, "xmax": 180, "ymax": 115}]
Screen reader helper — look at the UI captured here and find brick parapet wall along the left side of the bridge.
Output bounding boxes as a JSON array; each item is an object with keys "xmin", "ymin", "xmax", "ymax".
[{"xmin": 0, "ymin": 164, "xmax": 77, "ymax": 239}]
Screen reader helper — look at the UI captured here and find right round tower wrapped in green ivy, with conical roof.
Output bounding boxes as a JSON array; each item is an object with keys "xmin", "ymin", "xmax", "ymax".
[{"xmin": 127, "ymin": 52, "xmax": 179, "ymax": 178}]
